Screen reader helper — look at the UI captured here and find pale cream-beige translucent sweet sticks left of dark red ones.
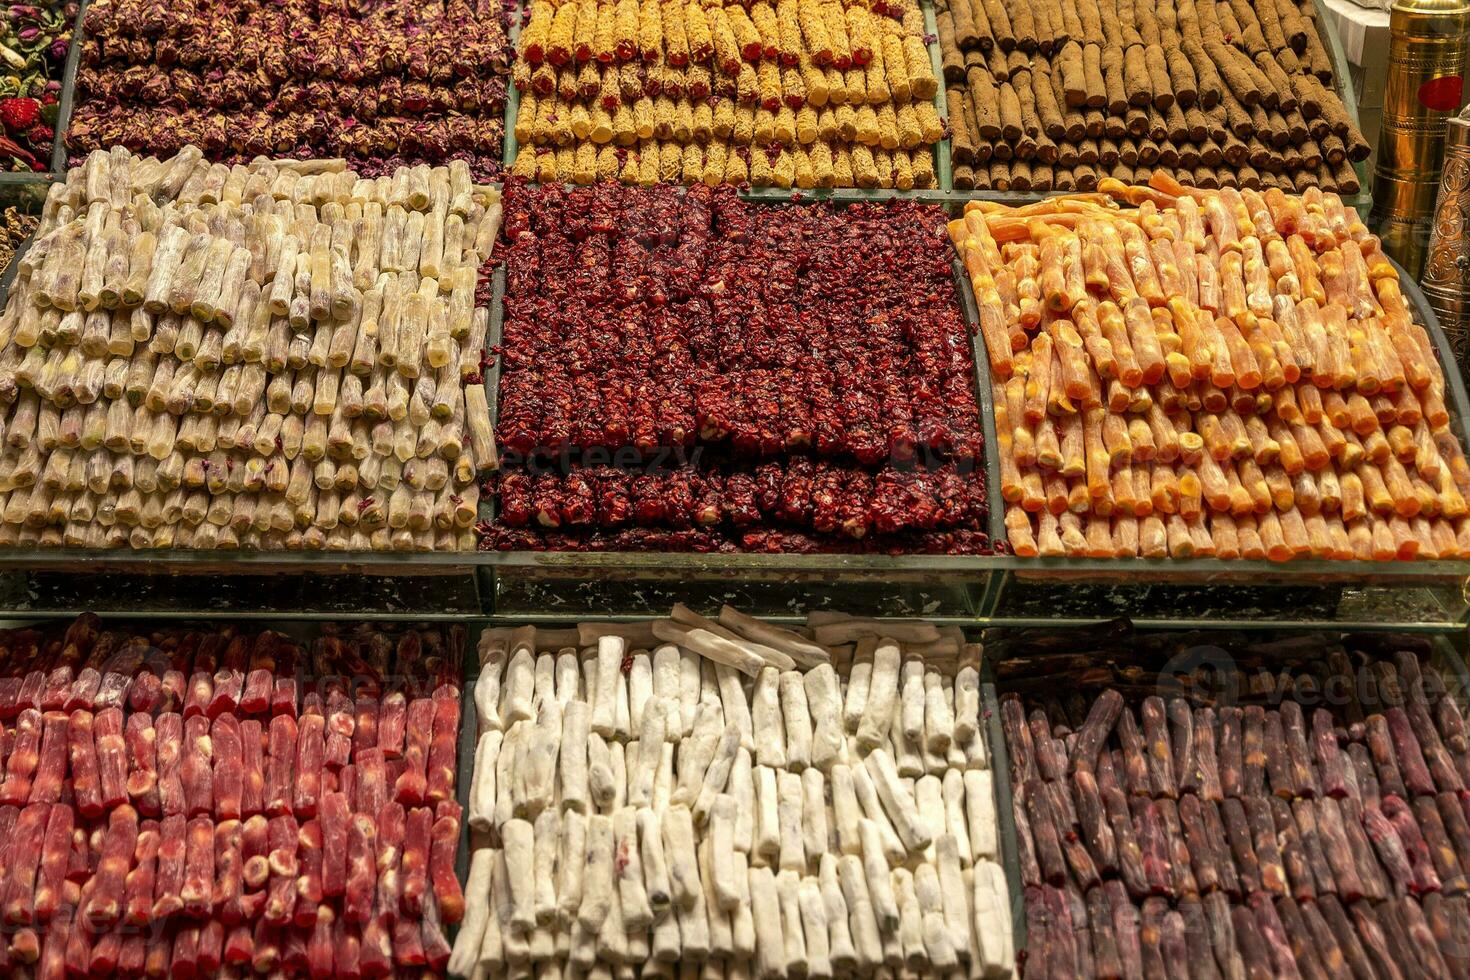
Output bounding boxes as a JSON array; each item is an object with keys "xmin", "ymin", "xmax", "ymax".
[{"xmin": 0, "ymin": 147, "xmax": 500, "ymax": 551}]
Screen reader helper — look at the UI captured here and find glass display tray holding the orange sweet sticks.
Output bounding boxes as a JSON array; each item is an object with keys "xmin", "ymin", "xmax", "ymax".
[{"xmin": 957, "ymin": 214, "xmax": 1470, "ymax": 626}]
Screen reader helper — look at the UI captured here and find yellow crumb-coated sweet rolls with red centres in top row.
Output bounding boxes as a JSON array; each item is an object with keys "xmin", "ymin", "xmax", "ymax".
[{"xmin": 512, "ymin": 0, "xmax": 945, "ymax": 190}]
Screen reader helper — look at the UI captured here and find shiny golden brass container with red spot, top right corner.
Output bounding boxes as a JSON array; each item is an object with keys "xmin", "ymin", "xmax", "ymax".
[{"xmin": 1372, "ymin": 0, "xmax": 1470, "ymax": 276}]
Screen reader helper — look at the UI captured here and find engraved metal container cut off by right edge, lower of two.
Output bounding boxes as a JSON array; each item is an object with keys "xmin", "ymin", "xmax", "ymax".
[{"xmin": 1421, "ymin": 109, "xmax": 1470, "ymax": 376}]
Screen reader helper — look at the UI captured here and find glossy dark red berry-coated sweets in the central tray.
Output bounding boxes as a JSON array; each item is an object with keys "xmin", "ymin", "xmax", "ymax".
[{"xmin": 482, "ymin": 184, "xmax": 989, "ymax": 554}]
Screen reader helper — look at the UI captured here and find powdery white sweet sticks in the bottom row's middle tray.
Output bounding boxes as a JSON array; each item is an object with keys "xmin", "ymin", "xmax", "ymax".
[{"xmin": 450, "ymin": 605, "xmax": 1013, "ymax": 977}]
